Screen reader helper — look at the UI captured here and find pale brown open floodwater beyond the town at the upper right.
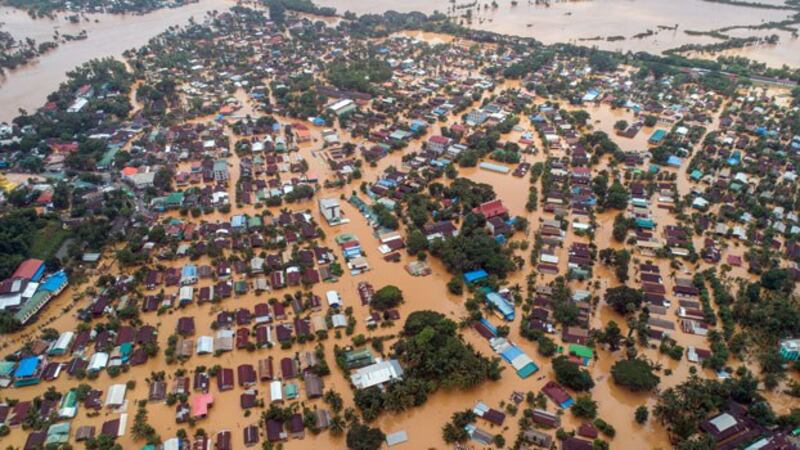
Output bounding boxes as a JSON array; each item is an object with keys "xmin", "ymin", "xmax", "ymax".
[{"xmin": 318, "ymin": 0, "xmax": 800, "ymax": 67}]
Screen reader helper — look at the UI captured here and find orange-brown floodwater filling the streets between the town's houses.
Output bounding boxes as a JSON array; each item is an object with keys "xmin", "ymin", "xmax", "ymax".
[{"xmin": 4, "ymin": 26, "xmax": 787, "ymax": 449}]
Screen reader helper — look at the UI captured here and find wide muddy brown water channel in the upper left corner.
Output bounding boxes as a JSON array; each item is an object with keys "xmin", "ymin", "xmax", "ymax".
[{"xmin": 0, "ymin": 0, "xmax": 235, "ymax": 122}]
